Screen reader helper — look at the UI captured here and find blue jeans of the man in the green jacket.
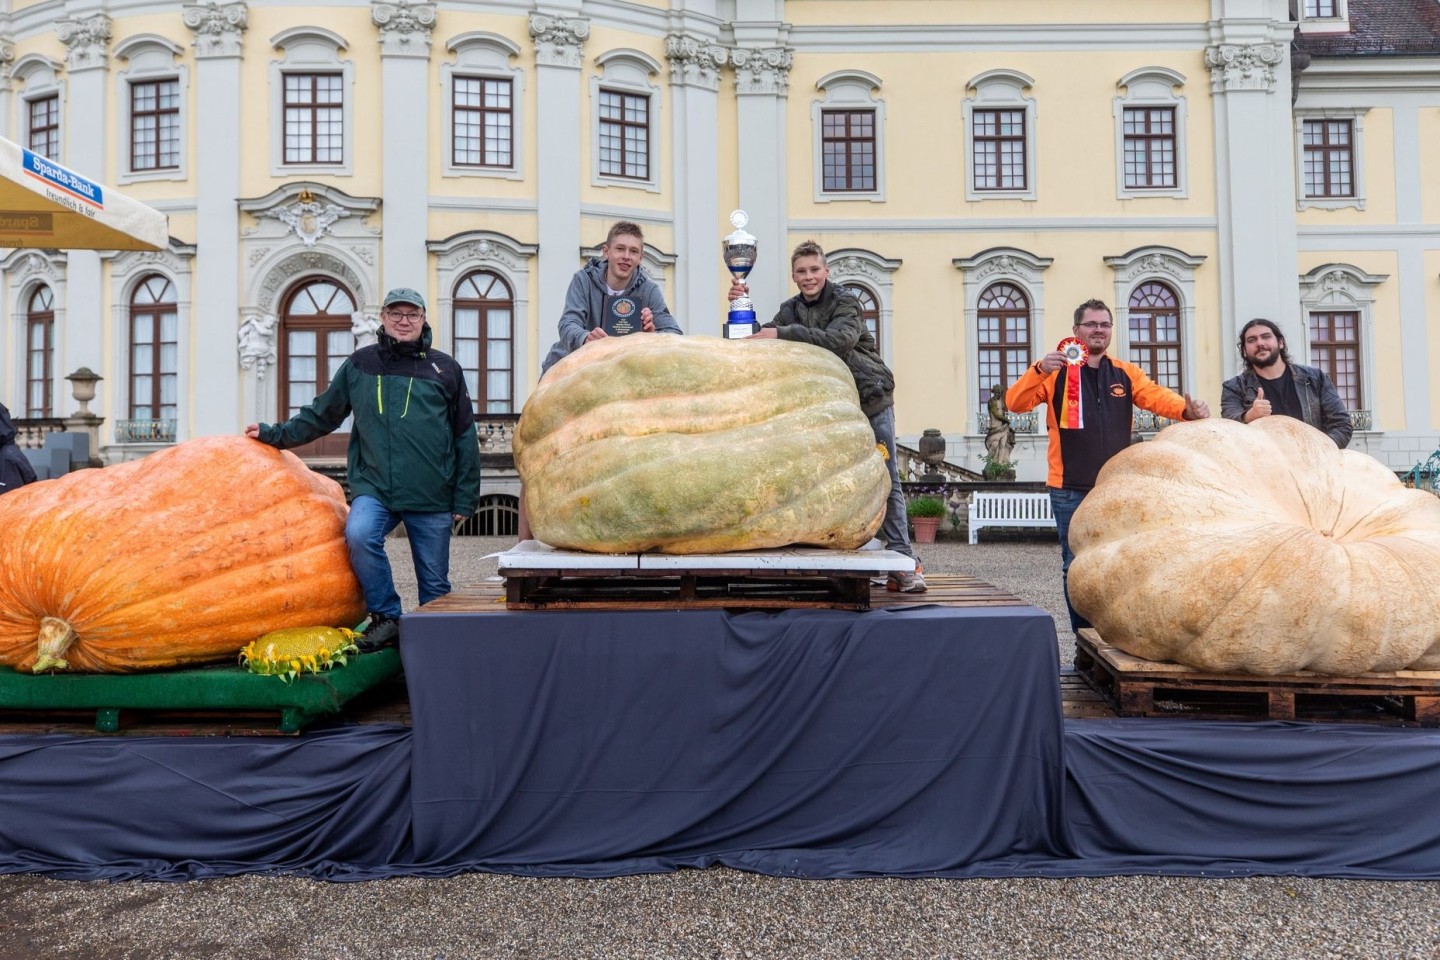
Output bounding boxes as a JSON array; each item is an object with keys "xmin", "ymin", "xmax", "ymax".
[{"xmin": 346, "ymin": 497, "xmax": 451, "ymax": 616}]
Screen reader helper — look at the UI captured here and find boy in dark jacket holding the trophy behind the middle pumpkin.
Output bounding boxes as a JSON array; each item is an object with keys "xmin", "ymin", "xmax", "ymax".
[{"xmin": 729, "ymin": 240, "xmax": 926, "ymax": 593}]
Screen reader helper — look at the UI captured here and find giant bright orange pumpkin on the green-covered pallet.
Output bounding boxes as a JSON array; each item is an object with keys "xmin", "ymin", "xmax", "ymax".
[{"xmin": 0, "ymin": 436, "xmax": 364, "ymax": 672}]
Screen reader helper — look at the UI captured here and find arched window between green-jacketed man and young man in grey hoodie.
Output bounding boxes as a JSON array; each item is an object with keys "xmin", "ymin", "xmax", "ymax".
[{"xmin": 454, "ymin": 271, "xmax": 516, "ymax": 416}]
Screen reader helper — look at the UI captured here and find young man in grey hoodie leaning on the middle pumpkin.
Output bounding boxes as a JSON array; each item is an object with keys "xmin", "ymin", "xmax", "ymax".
[{"xmin": 540, "ymin": 220, "xmax": 681, "ymax": 376}]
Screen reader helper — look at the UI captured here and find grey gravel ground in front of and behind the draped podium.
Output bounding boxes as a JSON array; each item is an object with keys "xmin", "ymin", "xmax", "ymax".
[{"xmin": 0, "ymin": 538, "xmax": 1440, "ymax": 960}]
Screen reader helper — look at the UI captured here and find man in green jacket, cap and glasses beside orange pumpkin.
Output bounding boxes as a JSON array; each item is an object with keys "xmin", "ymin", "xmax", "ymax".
[{"xmin": 245, "ymin": 286, "xmax": 480, "ymax": 652}]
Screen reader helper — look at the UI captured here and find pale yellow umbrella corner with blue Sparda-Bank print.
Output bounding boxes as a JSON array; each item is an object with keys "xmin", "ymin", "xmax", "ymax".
[{"xmin": 0, "ymin": 138, "xmax": 170, "ymax": 250}]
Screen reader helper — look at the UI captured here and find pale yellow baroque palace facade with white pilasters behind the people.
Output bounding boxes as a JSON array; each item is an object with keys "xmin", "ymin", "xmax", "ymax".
[{"xmin": 0, "ymin": 0, "xmax": 1440, "ymax": 499}]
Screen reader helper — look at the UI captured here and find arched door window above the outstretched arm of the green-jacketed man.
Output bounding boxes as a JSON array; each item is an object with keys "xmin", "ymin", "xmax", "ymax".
[{"xmin": 279, "ymin": 278, "xmax": 356, "ymax": 456}]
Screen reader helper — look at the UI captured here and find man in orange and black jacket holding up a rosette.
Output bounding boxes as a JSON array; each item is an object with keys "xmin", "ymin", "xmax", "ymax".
[{"xmin": 1005, "ymin": 299, "xmax": 1210, "ymax": 630}]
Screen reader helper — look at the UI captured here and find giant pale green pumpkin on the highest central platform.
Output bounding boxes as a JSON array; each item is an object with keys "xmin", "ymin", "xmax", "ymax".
[{"xmin": 514, "ymin": 334, "xmax": 890, "ymax": 554}]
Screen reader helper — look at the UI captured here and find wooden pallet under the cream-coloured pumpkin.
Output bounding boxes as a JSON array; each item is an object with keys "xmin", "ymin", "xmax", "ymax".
[{"xmin": 1076, "ymin": 629, "xmax": 1440, "ymax": 727}]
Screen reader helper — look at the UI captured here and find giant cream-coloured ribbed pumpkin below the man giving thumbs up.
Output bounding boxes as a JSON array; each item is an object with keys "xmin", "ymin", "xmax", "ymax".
[{"xmin": 1070, "ymin": 416, "xmax": 1440, "ymax": 676}]
